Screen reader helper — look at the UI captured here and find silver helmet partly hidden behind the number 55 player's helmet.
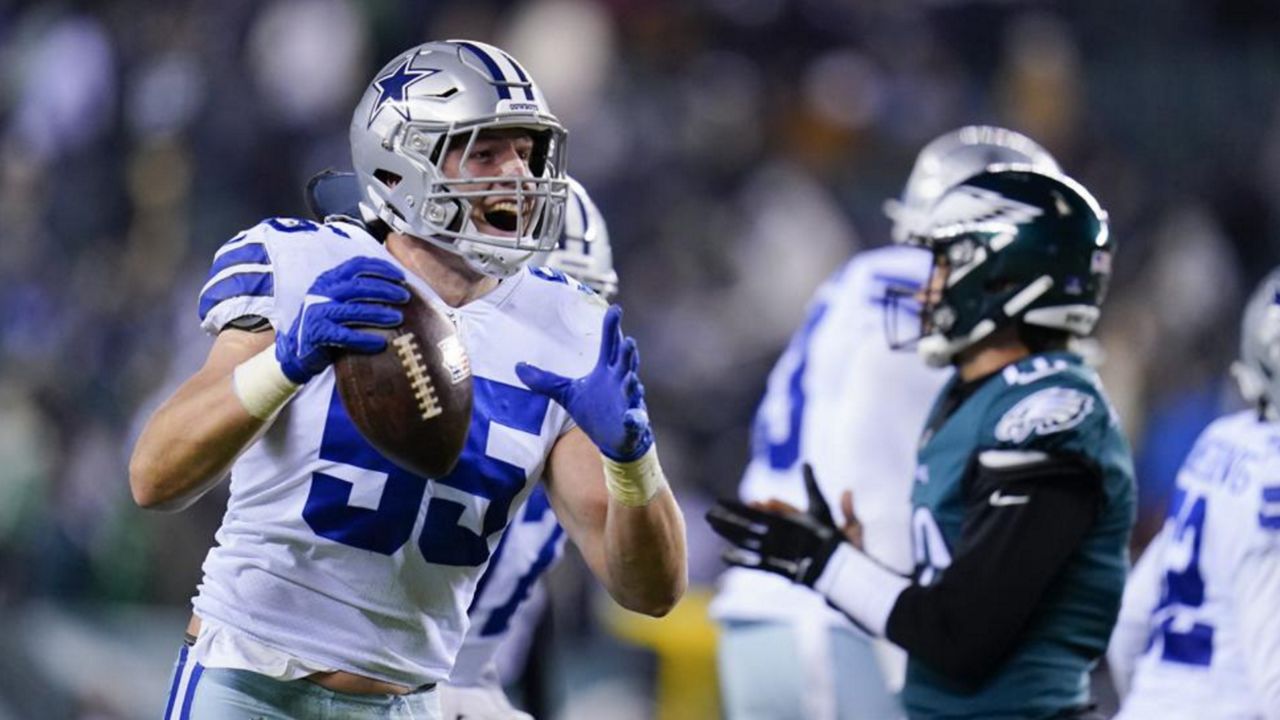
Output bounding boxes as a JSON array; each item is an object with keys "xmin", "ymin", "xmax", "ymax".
[{"xmin": 529, "ymin": 178, "xmax": 618, "ymax": 300}]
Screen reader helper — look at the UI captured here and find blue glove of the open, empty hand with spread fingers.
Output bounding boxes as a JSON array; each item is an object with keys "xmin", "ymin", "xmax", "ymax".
[{"xmin": 516, "ymin": 305, "xmax": 653, "ymax": 462}]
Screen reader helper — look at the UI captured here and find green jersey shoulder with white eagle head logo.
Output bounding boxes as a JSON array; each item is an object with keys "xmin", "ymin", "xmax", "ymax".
[{"xmin": 988, "ymin": 356, "xmax": 1111, "ymax": 456}]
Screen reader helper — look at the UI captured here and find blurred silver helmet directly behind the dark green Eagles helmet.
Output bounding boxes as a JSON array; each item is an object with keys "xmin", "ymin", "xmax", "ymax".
[{"xmin": 884, "ymin": 126, "xmax": 1062, "ymax": 242}]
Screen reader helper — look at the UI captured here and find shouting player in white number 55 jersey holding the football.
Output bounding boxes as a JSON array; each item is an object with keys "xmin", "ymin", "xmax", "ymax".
[{"xmin": 131, "ymin": 41, "xmax": 686, "ymax": 720}]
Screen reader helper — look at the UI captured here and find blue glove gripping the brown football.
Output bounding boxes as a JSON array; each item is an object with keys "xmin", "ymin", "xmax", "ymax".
[{"xmin": 275, "ymin": 258, "xmax": 410, "ymax": 384}]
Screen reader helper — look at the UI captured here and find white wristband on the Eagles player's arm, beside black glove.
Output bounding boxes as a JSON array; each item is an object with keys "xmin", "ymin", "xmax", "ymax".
[{"xmin": 813, "ymin": 543, "xmax": 911, "ymax": 637}]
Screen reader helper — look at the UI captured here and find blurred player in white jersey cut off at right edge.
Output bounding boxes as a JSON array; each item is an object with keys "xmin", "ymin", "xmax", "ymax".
[{"xmin": 1107, "ymin": 269, "xmax": 1280, "ymax": 720}]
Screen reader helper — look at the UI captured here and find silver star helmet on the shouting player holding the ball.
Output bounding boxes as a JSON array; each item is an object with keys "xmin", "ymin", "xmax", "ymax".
[{"xmin": 351, "ymin": 40, "xmax": 567, "ymax": 277}]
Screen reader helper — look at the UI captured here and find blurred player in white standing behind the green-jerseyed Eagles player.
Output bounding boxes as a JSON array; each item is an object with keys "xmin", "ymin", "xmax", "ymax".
[{"xmin": 712, "ymin": 126, "xmax": 1057, "ymax": 720}]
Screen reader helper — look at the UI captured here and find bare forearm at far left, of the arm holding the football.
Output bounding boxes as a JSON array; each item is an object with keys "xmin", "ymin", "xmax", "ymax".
[{"xmin": 129, "ymin": 374, "xmax": 265, "ymax": 510}]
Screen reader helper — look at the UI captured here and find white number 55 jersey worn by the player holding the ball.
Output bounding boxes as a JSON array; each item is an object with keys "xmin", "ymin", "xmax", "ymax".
[{"xmin": 195, "ymin": 219, "xmax": 604, "ymax": 687}]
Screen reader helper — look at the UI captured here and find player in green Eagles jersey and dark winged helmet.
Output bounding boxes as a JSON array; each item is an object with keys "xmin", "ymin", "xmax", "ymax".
[{"xmin": 708, "ymin": 167, "xmax": 1134, "ymax": 719}]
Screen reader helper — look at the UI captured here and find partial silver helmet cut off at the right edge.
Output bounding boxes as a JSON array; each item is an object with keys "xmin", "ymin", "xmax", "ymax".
[{"xmin": 1231, "ymin": 268, "xmax": 1280, "ymax": 420}]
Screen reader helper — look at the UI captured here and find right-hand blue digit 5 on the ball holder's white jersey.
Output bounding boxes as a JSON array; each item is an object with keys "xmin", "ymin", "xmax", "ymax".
[{"xmin": 417, "ymin": 377, "xmax": 550, "ymax": 565}]
